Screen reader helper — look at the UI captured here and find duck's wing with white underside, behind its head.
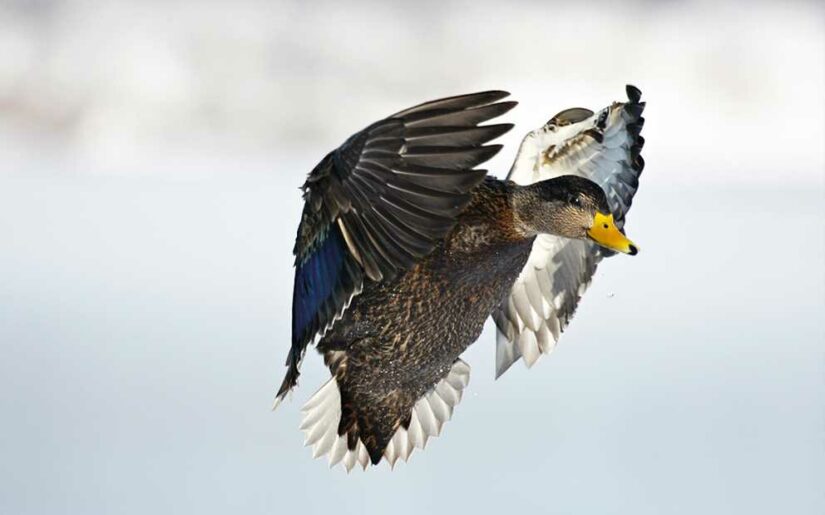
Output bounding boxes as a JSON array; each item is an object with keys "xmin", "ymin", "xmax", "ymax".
[{"xmin": 493, "ymin": 86, "xmax": 645, "ymax": 377}]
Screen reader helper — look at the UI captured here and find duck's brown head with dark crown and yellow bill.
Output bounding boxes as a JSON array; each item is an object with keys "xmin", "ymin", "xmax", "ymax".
[{"xmin": 513, "ymin": 175, "xmax": 639, "ymax": 255}]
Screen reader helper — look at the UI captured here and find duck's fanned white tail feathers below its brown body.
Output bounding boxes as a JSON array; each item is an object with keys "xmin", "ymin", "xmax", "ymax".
[{"xmin": 300, "ymin": 359, "xmax": 470, "ymax": 472}]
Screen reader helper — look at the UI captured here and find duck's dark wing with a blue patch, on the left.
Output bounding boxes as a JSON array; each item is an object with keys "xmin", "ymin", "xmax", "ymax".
[{"xmin": 276, "ymin": 91, "xmax": 516, "ymax": 403}]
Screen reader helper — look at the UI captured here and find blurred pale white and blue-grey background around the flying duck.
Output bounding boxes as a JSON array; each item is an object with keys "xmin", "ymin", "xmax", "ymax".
[{"xmin": 0, "ymin": 0, "xmax": 825, "ymax": 514}]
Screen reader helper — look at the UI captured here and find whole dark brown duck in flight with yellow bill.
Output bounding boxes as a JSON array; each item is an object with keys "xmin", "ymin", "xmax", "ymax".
[{"xmin": 276, "ymin": 86, "xmax": 644, "ymax": 471}]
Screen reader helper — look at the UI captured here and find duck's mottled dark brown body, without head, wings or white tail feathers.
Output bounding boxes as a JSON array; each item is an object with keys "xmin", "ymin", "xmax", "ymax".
[{"xmin": 318, "ymin": 179, "xmax": 533, "ymax": 463}]
